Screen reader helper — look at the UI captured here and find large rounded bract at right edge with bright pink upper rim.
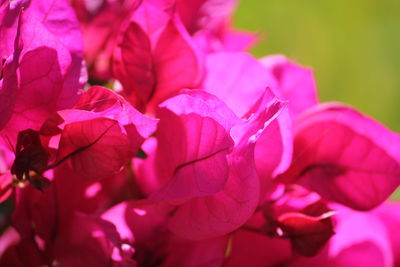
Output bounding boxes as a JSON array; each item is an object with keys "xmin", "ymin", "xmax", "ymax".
[{"xmin": 287, "ymin": 104, "xmax": 400, "ymax": 210}]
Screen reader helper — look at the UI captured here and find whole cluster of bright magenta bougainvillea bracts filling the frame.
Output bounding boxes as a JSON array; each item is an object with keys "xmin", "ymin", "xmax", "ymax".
[{"xmin": 0, "ymin": 0, "xmax": 400, "ymax": 267}]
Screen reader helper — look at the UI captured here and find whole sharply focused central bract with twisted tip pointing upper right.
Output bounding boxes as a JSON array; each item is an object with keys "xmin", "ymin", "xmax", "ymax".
[{"xmin": 138, "ymin": 91, "xmax": 282, "ymax": 239}]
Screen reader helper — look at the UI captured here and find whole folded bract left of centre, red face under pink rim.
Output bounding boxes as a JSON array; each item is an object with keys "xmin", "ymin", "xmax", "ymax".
[{"xmin": 41, "ymin": 87, "xmax": 157, "ymax": 180}]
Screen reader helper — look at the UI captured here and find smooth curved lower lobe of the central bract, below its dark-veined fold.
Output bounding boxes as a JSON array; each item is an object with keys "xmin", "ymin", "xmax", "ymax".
[{"xmin": 169, "ymin": 143, "xmax": 259, "ymax": 240}]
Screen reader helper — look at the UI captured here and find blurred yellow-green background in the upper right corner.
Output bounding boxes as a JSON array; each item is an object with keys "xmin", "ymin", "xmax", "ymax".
[{"xmin": 235, "ymin": 0, "xmax": 400, "ymax": 131}]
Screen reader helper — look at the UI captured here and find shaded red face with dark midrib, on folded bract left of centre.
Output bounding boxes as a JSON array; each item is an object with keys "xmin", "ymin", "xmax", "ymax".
[{"xmin": 57, "ymin": 118, "xmax": 136, "ymax": 179}]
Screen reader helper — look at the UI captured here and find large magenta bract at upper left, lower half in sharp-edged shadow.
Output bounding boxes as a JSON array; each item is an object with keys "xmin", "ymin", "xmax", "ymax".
[{"xmin": 2, "ymin": 1, "xmax": 86, "ymax": 140}]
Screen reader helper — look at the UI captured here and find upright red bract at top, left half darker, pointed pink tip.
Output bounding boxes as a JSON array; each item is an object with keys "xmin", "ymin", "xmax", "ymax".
[{"xmin": 114, "ymin": 2, "xmax": 202, "ymax": 110}]
